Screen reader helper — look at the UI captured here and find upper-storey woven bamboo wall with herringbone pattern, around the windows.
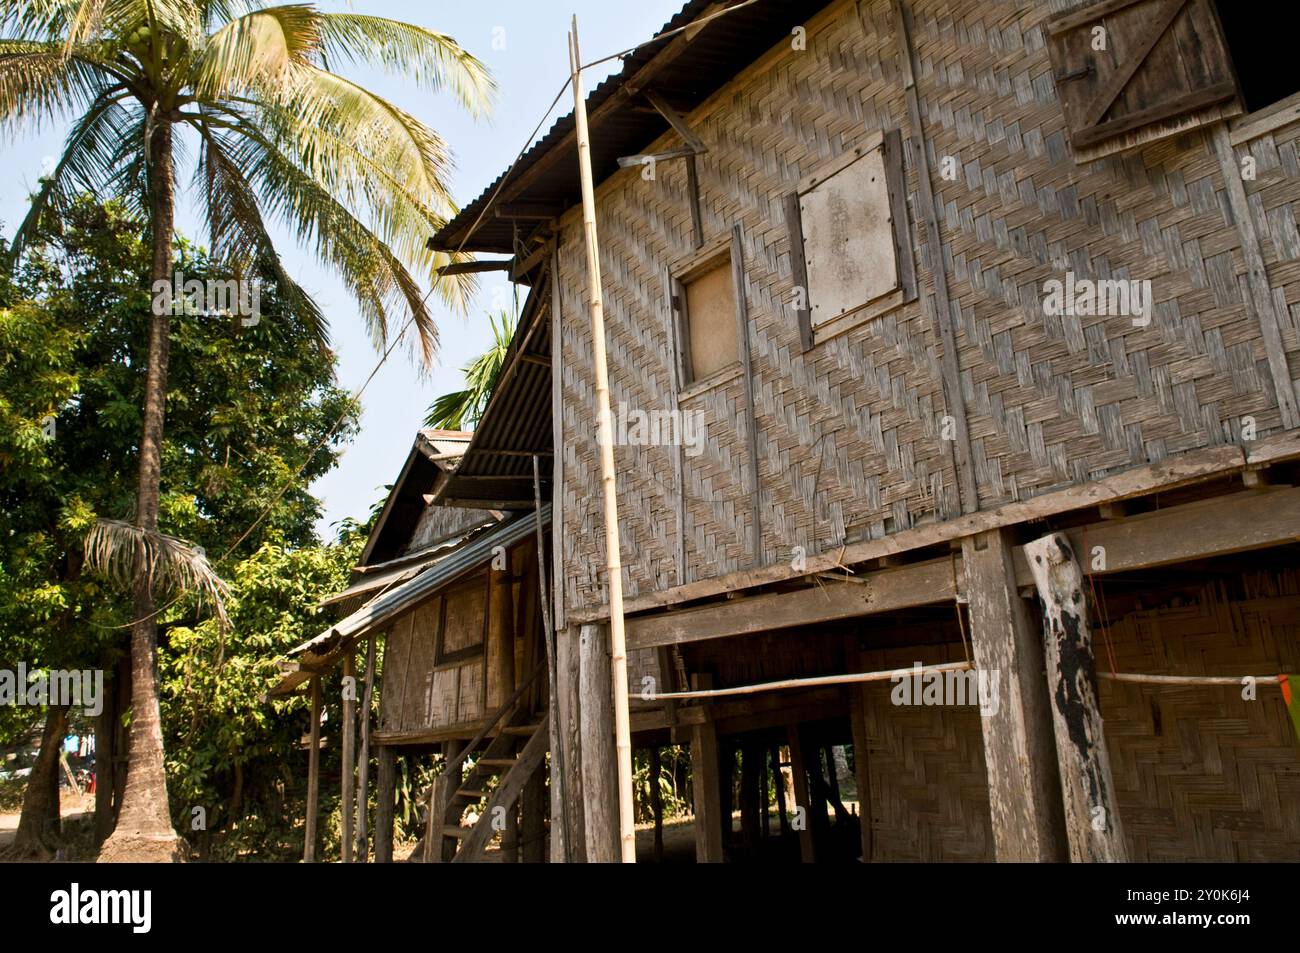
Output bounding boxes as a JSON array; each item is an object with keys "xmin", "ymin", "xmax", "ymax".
[{"xmin": 556, "ymin": 0, "xmax": 1300, "ymax": 607}]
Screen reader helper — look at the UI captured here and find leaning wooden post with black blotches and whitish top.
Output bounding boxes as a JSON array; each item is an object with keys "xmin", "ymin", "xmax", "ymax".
[{"xmin": 1024, "ymin": 533, "xmax": 1128, "ymax": 863}]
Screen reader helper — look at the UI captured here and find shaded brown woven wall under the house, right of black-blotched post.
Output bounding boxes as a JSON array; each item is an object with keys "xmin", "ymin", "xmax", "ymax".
[{"xmin": 1097, "ymin": 572, "xmax": 1300, "ymax": 862}]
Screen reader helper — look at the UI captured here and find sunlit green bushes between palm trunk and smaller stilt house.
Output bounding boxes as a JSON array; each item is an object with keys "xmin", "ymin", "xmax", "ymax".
[{"xmin": 160, "ymin": 520, "xmax": 365, "ymax": 859}]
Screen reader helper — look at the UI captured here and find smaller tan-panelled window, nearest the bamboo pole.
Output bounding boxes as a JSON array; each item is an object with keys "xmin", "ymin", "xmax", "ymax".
[{"xmin": 675, "ymin": 251, "xmax": 740, "ymax": 386}]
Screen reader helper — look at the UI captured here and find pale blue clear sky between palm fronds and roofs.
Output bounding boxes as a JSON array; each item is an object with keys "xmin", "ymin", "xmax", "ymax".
[{"xmin": 0, "ymin": 0, "xmax": 684, "ymax": 536}]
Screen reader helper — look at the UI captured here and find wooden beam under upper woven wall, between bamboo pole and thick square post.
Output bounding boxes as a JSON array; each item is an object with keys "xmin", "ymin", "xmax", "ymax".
[{"xmin": 628, "ymin": 559, "xmax": 956, "ymax": 649}]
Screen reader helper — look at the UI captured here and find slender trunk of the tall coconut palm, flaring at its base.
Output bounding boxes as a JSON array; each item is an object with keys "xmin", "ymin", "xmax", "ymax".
[{"xmin": 100, "ymin": 120, "xmax": 185, "ymax": 861}]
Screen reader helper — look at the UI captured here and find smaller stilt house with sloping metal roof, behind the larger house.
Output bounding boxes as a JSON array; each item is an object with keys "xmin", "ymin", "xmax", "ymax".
[{"xmin": 269, "ymin": 417, "xmax": 550, "ymax": 862}]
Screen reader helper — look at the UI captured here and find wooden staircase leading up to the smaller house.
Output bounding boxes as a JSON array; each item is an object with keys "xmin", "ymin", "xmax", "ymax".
[{"xmin": 423, "ymin": 671, "xmax": 550, "ymax": 863}]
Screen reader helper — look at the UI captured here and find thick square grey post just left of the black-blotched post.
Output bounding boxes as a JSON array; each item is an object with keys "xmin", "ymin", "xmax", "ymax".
[{"xmin": 962, "ymin": 529, "xmax": 1066, "ymax": 863}]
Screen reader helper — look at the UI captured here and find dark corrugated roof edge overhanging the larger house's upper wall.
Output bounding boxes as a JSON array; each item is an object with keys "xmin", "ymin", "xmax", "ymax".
[{"xmin": 430, "ymin": 0, "xmax": 829, "ymax": 255}]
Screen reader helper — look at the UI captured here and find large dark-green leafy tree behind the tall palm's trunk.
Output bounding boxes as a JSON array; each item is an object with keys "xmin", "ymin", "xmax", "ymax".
[{"xmin": 0, "ymin": 200, "xmax": 356, "ymax": 853}]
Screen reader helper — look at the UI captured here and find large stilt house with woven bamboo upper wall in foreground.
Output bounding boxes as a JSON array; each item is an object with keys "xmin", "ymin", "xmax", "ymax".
[{"xmin": 429, "ymin": 0, "xmax": 1300, "ymax": 861}]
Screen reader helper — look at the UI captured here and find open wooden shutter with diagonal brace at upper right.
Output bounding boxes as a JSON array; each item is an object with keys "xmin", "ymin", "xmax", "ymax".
[{"xmin": 1047, "ymin": 0, "xmax": 1242, "ymax": 161}]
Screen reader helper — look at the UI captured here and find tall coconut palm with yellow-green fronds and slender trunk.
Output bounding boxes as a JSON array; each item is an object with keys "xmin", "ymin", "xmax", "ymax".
[{"xmin": 0, "ymin": 0, "xmax": 494, "ymax": 859}]
